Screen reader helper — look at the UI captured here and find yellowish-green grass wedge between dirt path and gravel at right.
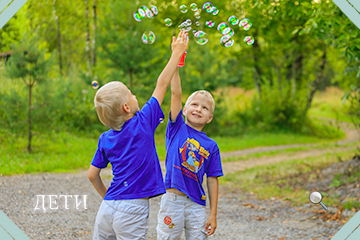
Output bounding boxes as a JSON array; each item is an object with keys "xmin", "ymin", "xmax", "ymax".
[{"xmin": 220, "ymin": 146, "xmax": 358, "ymax": 206}]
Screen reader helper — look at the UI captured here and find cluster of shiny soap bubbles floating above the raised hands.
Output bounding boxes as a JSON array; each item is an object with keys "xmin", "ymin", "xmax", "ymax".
[{"xmin": 134, "ymin": 2, "xmax": 254, "ymax": 47}]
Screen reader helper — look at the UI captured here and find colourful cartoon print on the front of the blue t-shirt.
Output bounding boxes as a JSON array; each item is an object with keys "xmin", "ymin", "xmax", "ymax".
[{"xmin": 180, "ymin": 138, "xmax": 208, "ymax": 173}]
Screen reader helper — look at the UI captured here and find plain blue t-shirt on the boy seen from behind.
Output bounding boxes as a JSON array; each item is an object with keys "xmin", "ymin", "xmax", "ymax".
[{"xmin": 91, "ymin": 97, "xmax": 166, "ymax": 200}]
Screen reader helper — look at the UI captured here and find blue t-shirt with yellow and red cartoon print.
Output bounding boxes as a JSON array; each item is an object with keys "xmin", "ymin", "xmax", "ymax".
[{"xmin": 165, "ymin": 111, "xmax": 223, "ymax": 206}]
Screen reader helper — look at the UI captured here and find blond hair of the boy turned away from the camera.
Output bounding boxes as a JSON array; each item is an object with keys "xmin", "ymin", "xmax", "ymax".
[{"xmin": 94, "ymin": 81, "xmax": 129, "ymax": 131}]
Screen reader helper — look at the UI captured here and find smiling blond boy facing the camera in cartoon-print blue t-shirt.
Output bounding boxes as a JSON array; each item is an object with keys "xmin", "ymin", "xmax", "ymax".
[{"xmin": 157, "ymin": 68, "xmax": 223, "ymax": 240}]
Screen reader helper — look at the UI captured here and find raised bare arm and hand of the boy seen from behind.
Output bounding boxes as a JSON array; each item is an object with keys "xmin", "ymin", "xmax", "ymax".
[{"xmin": 152, "ymin": 31, "xmax": 189, "ymax": 105}]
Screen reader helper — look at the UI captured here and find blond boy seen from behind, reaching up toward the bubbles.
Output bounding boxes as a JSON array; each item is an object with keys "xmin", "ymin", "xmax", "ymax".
[{"xmin": 88, "ymin": 31, "xmax": 189, "ymax": 240}]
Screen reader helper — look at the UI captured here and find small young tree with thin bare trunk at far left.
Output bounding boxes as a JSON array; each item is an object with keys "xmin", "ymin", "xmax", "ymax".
[{"xmin": 5, "ymin": 36, "xmax": 51, "ymax": 153}]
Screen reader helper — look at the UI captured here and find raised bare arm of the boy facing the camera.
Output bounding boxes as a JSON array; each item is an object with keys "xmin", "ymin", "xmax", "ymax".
[{"xmin": 170, "ymin": 69, "xmax": 182, "ymax": 122}]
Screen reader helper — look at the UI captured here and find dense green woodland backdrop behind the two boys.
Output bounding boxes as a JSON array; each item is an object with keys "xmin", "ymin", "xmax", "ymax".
[{"xmin": 0, "ymin": 0, "xmax": 360, "ymax": 145}]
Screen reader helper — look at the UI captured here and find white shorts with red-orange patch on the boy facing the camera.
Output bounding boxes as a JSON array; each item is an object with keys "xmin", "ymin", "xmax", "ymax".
[{"xmin": 156, "ymin": 193, "xmax": 207, "ymax": 240}]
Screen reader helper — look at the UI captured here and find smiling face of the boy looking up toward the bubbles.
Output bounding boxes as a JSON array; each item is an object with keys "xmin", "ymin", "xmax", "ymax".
[{"xmin": 183, "ymin": 94, "xmax": 213, "ymax": 131}]
